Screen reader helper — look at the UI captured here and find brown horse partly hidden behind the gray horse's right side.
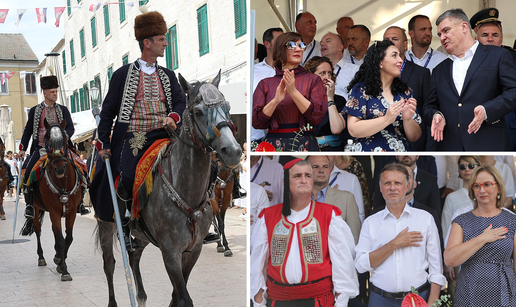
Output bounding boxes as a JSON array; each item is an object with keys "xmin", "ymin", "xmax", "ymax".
[{"xmin": 210, "ymin": 162, "xmax": 236, "ymax": 257}]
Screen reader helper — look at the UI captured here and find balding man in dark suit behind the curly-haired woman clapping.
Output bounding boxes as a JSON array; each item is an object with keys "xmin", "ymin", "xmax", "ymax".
[{"xmin": 383, "ymin": 26, "xmax": 430, "ymax": 151}]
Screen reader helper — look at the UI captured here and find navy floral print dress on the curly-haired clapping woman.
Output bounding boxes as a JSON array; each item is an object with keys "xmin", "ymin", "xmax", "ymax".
[{"xmin": 343, "ymin": 83, "xmax": 421, "ymax": 152}]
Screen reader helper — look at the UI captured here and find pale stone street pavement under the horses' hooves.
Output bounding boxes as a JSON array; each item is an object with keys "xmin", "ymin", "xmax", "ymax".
[{"xmin": 0, "ymin": 197, "xmax": 247, "ymax": 307}]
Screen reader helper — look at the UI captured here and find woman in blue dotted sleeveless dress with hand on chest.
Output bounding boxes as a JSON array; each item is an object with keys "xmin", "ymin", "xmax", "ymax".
[{"xmin": 444, "ymin": 165, "xmax": 516, "ymax": 307}]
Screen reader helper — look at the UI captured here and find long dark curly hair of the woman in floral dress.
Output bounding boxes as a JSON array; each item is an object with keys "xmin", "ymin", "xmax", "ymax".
[{"xmin": 347, "ymin": 40, "xmax": 408, "ymax": 97}]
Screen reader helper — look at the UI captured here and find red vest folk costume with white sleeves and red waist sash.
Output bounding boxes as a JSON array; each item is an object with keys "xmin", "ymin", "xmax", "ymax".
[{"xmin": 251, "ymin": 163, "xmax": 359, "ymax": 307}]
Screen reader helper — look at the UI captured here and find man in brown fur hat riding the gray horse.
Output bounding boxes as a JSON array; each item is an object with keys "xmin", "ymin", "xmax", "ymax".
[{"xmin": 90, "ymin": 12, "xmax": 186, "ymax": 250}]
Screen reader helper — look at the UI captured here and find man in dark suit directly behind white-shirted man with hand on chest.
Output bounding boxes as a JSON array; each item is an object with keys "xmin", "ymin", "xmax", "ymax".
[{"xmin": 373, "ymin": 156, "xmax": 442, "ymax": 220}]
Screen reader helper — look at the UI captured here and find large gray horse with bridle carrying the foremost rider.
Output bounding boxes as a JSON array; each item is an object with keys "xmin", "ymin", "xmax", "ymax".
[{"xmin": 97, "ymin": 71, "xmax": 242, "ymax": 307}]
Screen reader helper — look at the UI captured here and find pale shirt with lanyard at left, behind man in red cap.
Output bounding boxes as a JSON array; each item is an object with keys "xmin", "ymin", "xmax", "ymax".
[{"xmin": 250, "ymin": 156, "xmax": 284, "ymax": 206}]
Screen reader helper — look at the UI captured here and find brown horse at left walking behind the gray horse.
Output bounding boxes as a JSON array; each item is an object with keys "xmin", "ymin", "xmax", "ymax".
[{"xmin": 21, "ymin": 119, "xmax": 81, "ymax": 281}]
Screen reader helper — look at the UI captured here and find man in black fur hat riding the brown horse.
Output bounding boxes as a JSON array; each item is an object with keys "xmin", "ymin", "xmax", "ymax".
[{"xmin": 19, "ymin": 76, "xmax": 90, "ymax": 218}]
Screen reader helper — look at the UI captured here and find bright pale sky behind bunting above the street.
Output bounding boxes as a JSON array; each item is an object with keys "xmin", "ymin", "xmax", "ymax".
[{"xmin": 0, "ymin": 0, "xmax": 67, "ymax": 62}]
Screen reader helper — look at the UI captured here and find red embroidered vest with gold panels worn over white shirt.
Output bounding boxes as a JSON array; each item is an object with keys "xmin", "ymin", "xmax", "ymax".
[{"xmin": 260, "ymin": 201, "xmax": 341, "ymax": 284}]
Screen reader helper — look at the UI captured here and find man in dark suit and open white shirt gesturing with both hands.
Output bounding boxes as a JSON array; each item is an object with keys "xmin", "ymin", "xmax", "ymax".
[{"xmin": 423, "ymin": 9, "xmax": 516, "ymax": 151}]
